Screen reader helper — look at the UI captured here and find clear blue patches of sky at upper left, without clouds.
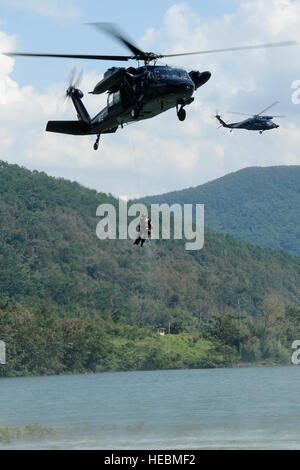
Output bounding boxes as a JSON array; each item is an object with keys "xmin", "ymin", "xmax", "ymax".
[{"xmin": 0, "ymin": 0, "xmax": 236, "ymax": 90}]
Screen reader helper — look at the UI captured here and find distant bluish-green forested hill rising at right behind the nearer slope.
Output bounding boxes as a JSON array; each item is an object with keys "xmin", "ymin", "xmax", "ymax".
[{"xmin": 139, "ymin": 166, "xmax": 300, "ymax": 255}]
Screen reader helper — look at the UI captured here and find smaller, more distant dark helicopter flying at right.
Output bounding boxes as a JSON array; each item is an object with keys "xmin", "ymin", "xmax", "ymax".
[{"xmin": 215, "ymin": 101, "xmax": 284, "ymax": 134}]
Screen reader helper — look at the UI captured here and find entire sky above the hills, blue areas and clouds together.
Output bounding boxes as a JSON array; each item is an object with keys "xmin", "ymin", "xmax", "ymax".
[{"xmin": 0, "ymin": 0, "xmax": 300, "ymax": 196}]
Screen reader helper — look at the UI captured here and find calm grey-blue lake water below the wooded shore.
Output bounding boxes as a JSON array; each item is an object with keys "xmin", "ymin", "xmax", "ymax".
[{"xmin": 0, "ymin": 366, "xmax": 300, "ymax": 450}]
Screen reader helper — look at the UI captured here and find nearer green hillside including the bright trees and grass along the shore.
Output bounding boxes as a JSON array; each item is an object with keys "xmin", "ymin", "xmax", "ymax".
[{"xmin": 0, "ymin": 162, "xmax": 300, "ymax": 376}]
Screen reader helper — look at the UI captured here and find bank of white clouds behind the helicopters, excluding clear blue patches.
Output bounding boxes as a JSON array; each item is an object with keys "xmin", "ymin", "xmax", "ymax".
[{"xmin": 0, "ymin": 0, "xmax": 300, "ymax": 195}]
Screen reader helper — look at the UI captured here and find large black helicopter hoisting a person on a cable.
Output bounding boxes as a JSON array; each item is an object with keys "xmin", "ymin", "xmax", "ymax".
[{"xmin": 6, "ymin": 23, "xmax": 297, "ymax": 150}]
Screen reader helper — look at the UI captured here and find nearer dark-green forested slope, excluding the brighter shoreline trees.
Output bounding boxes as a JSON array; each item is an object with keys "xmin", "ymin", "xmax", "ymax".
[{"xmin": 0, "ymin": 158, "xmax": 300, "ymax": 325}]
